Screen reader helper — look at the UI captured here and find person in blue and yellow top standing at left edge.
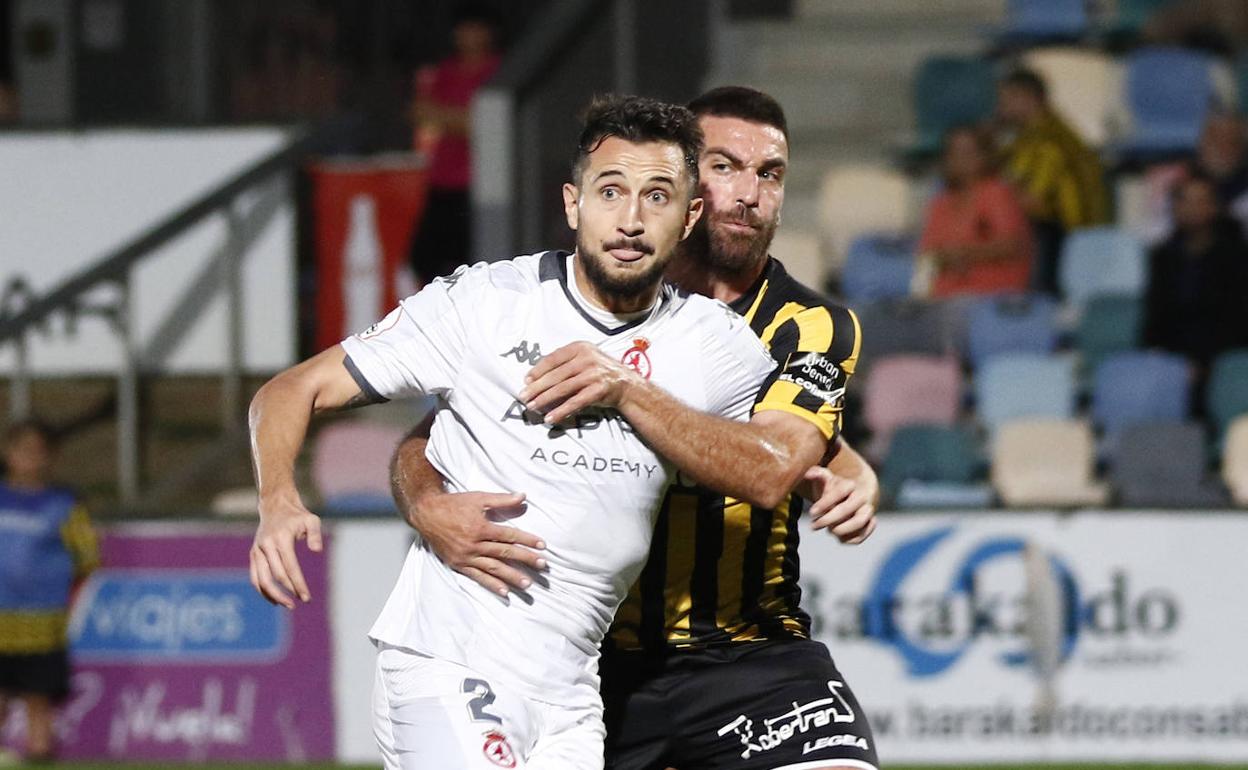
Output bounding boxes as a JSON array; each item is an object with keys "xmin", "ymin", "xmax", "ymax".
[{"xmin": 0, "ymin": 421, "xmax": 99, "ymax": 763}]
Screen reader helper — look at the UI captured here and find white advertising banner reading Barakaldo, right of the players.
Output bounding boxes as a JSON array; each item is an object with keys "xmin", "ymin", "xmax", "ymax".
[{"xmin": 801, "ymin": 512, "xmax": 1248, "ymax": 765}]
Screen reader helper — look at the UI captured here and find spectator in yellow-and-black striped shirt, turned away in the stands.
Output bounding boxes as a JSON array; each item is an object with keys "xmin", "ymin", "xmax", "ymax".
[{"xmin": 997, "ymin": 70, "xmax": 1109, "ymax": 295}]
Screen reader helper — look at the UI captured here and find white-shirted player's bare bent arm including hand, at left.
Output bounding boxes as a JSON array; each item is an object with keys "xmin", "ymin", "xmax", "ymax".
[{"xmin": 248, "ymin": 346, "xmax": 369, "ymax": 609}]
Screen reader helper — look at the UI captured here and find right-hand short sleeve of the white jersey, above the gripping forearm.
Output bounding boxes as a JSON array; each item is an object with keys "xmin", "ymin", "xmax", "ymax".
[{"xmin": 705, "ymin": 302, "xmax": 776, "ymax": 422}]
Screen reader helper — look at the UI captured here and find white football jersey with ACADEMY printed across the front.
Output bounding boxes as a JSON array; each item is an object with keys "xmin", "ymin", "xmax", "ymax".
[{"xmin": 342, "ymin": 251, "xmax": 775, "ymax": 705}]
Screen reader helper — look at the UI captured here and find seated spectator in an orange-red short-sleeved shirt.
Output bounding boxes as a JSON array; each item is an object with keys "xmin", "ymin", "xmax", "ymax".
[{"xmin": 919, "ymin": 126, "xmax": 1032, "ymax": 297}]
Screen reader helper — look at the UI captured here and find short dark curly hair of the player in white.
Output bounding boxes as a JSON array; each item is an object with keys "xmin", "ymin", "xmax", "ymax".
[{"xmin": 572, "ymin": 96, "xmax": 703, "ymax": 195}]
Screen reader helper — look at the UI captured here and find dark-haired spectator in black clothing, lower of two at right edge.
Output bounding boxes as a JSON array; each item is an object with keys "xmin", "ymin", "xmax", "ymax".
[{"xmin": 1143, "ymin": 173, "xmax": 1248, "ymax": 372}]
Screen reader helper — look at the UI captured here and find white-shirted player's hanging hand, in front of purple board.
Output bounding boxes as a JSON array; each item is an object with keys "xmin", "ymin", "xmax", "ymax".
[{"xmin": 251, "ymin": 494, "xmax": 321, "ymax": 609}]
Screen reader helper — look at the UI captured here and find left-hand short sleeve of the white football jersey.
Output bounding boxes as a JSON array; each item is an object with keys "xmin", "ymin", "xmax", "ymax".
[{"xmin": 342, "ymin": 265, "xmax": 488, "ymax": 399}]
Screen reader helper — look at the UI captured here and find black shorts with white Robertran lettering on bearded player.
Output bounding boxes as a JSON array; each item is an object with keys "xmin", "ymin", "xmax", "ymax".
[{"xmin": 600, "ymin": 639, "xmax": 880, "ymax": 770}]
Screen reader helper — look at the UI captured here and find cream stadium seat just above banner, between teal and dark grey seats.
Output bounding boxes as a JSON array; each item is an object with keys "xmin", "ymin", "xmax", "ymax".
[{"xmin": 992, "ymin": 419, "xmax": 1108, "ymax": 508}]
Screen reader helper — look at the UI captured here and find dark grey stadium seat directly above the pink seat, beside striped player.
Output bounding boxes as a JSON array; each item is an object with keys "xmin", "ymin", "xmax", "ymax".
[{"xmin": 855, "ymin": 300, "xmax": 953, "ymax": 379}]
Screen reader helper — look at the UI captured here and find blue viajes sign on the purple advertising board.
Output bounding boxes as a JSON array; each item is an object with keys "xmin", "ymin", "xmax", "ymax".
[{"xmin": 70, "ymin": 569, "xmax": 290, "ymax": 663}]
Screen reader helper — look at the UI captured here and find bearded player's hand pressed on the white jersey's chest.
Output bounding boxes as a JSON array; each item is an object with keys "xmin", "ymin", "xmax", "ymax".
[{"xmin": 520, "ymin": 342, "xmax": 640, "ymax": 424}]
